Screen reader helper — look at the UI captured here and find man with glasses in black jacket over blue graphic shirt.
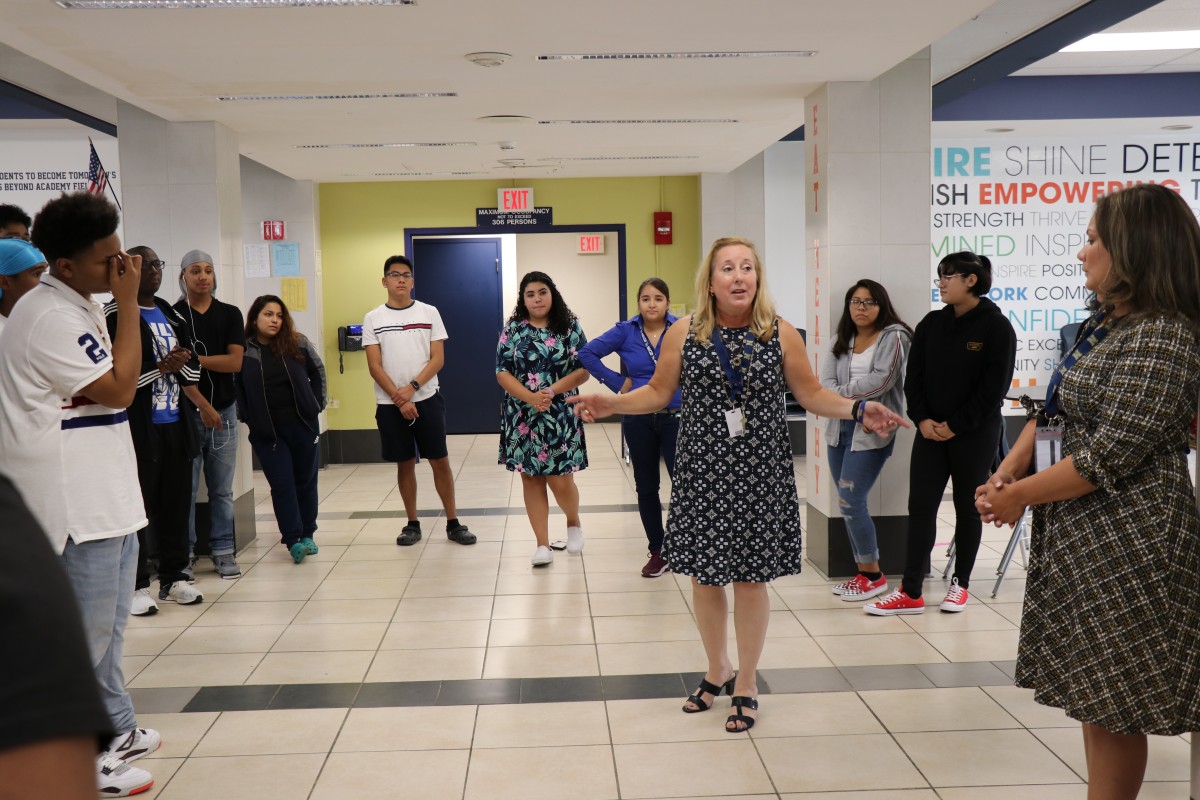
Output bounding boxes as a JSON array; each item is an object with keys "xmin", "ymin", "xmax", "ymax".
[{"xmin": 104, "ymin": 247, "xmax": 208, "ymax": 616}]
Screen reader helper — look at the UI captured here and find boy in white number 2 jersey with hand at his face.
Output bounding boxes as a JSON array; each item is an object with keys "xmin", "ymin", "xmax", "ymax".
[{"xmin": 0, "ymin": 192, "xmax": 162, "ymax": 796}]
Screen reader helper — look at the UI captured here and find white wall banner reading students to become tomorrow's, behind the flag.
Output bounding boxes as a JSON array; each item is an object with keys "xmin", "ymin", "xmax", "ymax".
[{"xmin": 0, "ymin": 125, "xmax": 121, "ymax": 217}]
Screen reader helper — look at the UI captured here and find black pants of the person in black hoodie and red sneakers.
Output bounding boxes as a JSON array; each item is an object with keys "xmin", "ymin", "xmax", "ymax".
[{"xmin": 901, "ymin": 415, "xmax": 1001, "ymax": 597}]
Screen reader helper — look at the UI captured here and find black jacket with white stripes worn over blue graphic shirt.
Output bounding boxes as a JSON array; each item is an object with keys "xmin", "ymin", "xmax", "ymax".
[{"xmin": 104, "ymin": 297, "xmax": 200, "ymax": 462}]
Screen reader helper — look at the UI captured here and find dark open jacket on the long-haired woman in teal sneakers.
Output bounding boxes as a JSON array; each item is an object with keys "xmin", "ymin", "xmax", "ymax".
[{"xmin": 233, "ymin": 336, "xmax": 325, "ymax": 441}]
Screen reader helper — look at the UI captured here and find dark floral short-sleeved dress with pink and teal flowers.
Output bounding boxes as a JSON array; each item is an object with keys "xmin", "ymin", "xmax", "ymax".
[{"xmin": 496, "ymin": 320, "xmax": 588, "ymax": 475}]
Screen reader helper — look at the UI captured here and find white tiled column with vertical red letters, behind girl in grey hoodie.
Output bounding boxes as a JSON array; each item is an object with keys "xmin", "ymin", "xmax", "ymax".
[{"xmin": 804, "ymin": 49, "xmax": 931, "ymax": 576}]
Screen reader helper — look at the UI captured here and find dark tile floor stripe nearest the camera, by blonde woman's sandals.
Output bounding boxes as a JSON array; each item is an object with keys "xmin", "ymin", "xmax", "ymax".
[{"xmin": 169, "ymin": 661, "xmax": 1013, "ymax": 714}]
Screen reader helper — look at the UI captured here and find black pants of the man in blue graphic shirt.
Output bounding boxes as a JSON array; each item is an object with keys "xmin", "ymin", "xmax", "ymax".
[{"xmin": 134, "ymin": 420, "xmax": 192, "ymax": 589}]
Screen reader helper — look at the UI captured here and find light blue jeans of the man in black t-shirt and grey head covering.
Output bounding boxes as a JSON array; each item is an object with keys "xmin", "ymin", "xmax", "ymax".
[{"xmin": 187, "ymin": 403, "xmax": 238, "ymax": 555}]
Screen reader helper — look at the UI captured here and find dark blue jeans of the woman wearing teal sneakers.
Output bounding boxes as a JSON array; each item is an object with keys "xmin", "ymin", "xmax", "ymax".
[{"xmin": 250, "ymin": 422, "xmax": 320, "ymax": 547}]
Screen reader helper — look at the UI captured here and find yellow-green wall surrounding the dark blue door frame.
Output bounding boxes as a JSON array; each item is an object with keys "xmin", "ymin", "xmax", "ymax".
[{"xmin": 319, "ymin": 176, "xmax": 701, "ymax": 431}]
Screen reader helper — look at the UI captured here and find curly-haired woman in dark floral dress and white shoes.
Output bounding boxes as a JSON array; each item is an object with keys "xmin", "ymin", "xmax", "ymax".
[{"xmin": 496, "ymin": 272, "xmax": 588, "ymax": 566}]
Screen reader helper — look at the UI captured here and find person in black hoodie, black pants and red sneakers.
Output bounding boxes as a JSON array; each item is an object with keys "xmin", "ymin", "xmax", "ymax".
[{"xmin": 863, "ymin": 252, "xmax": 1016, "ymax": 616}]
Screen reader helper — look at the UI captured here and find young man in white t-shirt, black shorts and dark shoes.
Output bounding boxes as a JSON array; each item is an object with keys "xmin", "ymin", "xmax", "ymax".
[{"xmin": 362, "ymin": 255, "xmax": 475, "ymax": 547}]
